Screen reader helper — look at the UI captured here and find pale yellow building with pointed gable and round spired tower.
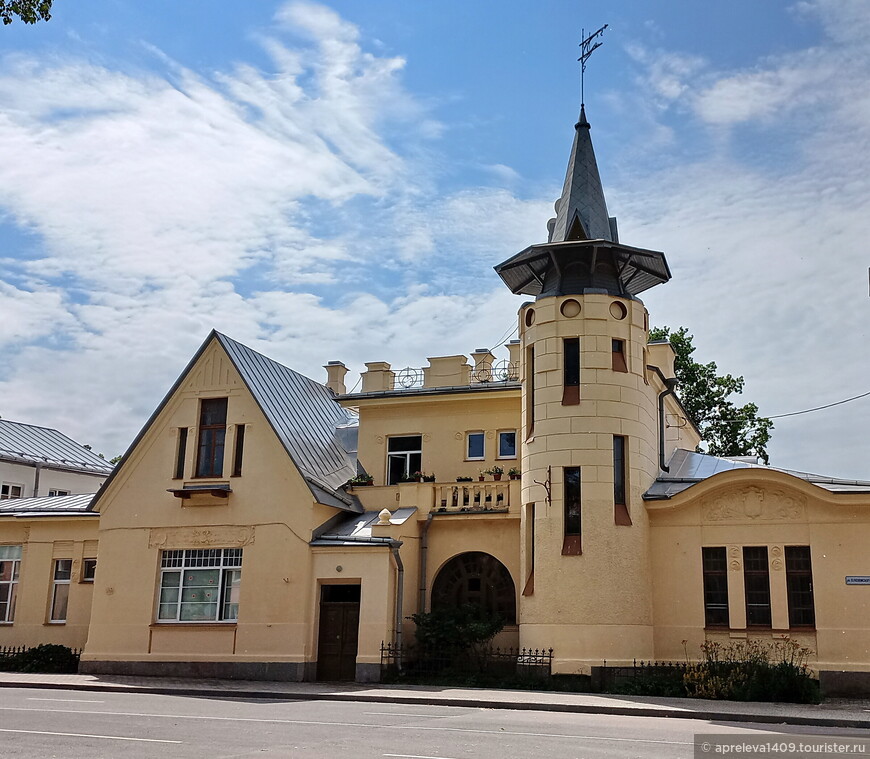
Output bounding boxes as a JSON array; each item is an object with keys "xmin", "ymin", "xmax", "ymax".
[{"xmin": 0, "ymin": 99, "xmax": 870, "ymax": 692}]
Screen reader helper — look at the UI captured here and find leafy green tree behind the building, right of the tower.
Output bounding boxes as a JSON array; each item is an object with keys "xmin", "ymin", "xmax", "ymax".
[{"xmin": 649, "ymin": 327, "xmax": 773, "ymax": 463}]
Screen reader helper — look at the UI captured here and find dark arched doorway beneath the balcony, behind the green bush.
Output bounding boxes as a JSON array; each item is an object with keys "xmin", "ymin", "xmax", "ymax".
[{"xmin": 432, "ymin": 551, "xmax": 517, "ymax": 625}]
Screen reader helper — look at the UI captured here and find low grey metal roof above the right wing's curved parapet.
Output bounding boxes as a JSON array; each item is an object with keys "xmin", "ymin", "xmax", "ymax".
[{"xmin": 643, "ymin": 448, "xmax": 870, "ymax": 501}]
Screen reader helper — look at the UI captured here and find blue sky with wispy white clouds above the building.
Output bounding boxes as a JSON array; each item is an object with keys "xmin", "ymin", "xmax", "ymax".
[{"xmin": 0, "ymin": 0, "xmax": 870, "ymax": 479}]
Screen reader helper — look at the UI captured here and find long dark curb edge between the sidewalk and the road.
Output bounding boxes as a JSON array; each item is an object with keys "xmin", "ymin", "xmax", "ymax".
[{"xmin": 0, "ymin": 681, "xmax": 870, "ymax": 730}]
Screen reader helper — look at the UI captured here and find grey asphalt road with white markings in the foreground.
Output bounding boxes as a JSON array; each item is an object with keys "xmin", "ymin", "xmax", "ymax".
[{"xmin": 0, "ymin": 688, "xmax": 870, "ymax": 759}]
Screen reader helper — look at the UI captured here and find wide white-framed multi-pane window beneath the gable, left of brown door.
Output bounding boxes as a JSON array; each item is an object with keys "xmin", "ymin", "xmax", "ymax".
[{"xmin": 157, "ymin": 548, "xmax": 242, "ymax": 622}]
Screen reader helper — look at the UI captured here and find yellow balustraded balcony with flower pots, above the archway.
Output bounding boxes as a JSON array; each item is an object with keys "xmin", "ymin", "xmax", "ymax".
[{"xmin": 353, "ymin": 480, "xmax": 520, "ymax": 516}]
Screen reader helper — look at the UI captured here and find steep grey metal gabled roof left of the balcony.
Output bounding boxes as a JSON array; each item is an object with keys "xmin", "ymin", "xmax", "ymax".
[{"xmin": 94, "ymin": 330, "xmax": 363, "ymax": 513}]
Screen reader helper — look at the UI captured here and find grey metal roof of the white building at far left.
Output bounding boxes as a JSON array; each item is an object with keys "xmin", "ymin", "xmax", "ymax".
[{"xmin": 0, "ymin": 419, "xmax": 113, "ymax": 475}]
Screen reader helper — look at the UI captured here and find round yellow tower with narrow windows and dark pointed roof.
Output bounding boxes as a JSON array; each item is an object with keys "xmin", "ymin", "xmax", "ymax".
[{"xmin": 495, "ymin": 104, "xmax": 670, "ymax": 673}]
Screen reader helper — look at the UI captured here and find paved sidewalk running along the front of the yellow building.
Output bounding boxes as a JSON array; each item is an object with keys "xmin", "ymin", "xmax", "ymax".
[{"xmin": 0, "ymin": 672, "xmax": 870, "ymax": 729}]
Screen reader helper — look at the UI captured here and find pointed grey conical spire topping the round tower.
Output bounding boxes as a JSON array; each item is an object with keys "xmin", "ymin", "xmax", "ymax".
[{"xmin": 548, "ymin": 105, "xmax": 615, "ymax": 242}]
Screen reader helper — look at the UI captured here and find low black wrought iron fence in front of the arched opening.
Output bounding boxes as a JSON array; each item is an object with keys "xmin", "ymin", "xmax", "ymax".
[{"xmin": 381, "ymin": 643, "xmax": 553, "ymax": 679}]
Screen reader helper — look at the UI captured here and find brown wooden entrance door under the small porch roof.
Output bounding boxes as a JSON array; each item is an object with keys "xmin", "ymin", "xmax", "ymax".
[{"xmin": 317, "ymin": 585, "xmax": 360, "ymax": 680}]
